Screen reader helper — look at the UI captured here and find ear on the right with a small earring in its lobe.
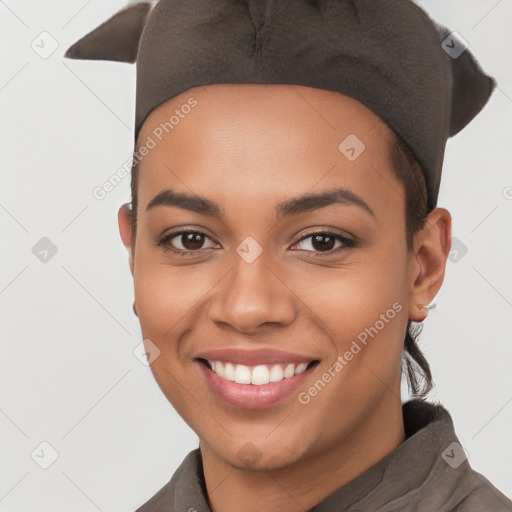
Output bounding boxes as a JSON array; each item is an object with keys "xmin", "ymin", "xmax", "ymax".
[{"xmin": 408, "ymin": 208, "xmax": 452, "ymax": 322}]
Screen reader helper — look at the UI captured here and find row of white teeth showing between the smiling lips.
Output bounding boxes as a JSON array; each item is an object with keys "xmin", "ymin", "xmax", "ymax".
[{"xmin": 208, "ymin": 361, "xmax": 308, "ymax": 386}]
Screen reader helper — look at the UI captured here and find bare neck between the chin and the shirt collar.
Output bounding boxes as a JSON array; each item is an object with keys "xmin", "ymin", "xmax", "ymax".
[{"xmin": 201, "ymin": 400, "xmax": 405, "ymax": 512}]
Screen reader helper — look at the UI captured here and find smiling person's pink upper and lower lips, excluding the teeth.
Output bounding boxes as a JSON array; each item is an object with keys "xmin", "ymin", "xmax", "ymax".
[{"xmin": 196, "ymin": 349, "xmax": 318, "ymax": 409}]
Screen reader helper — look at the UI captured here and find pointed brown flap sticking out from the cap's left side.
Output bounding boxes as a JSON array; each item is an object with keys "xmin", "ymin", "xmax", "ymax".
[{"xmin": 64, "ymin": 2, "xmax": 155, "ymax": 63}]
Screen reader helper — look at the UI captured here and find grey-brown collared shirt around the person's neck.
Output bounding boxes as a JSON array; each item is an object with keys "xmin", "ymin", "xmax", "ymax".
[{"xmin": 136, "ymin": 400, "xmax": 512, "ymax": 512}]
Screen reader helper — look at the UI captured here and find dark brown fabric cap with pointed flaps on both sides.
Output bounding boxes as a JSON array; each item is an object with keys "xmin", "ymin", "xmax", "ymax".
[{"xmin": 66, "ymin": 0, "xmax": 495, "ymax": 211}]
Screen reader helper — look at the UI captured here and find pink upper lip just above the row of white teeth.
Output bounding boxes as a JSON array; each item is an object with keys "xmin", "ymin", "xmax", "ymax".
[{"xmin": 196, "ymin": 348, "xmax": 316, "ymax": 366}]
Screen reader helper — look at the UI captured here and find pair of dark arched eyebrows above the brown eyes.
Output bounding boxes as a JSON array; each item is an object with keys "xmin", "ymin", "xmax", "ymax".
[{"xmin": 146, "ymin": 187, "xmax": 375, "ymax": 220}]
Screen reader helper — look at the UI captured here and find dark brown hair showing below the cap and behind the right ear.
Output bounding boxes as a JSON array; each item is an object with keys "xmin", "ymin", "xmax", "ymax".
[{"xmin": 131, "ymin": 132, "xmax": 434, "ymax": 399}]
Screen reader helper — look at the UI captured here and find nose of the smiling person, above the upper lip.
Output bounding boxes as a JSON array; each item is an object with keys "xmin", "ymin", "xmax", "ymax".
[{"xmin": 209, "ymin": 256, "xmax": 297, "ymax": 334}]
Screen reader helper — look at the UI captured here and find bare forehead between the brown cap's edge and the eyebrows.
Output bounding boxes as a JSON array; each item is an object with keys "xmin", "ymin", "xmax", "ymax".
[{"xmin": 137, "ymin": 83, "xmax": 401, "ymax": 220}]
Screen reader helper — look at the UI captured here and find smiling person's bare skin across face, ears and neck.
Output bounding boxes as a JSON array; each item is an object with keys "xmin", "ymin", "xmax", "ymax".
[{"xmin": 119, "ymin": 84, "xmax": 451, "ymax": 512}]
